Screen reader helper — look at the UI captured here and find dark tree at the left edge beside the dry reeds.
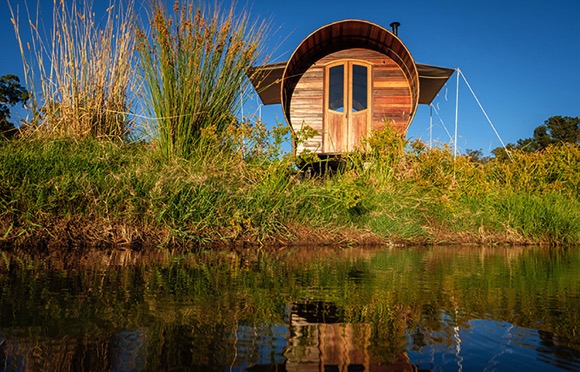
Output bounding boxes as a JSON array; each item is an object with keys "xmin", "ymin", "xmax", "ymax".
[{"xmin": 0, "ymin": 74, "xmax": 30, "ymax": 138}]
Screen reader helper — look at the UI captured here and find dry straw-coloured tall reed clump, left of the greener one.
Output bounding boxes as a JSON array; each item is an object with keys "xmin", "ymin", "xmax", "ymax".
[{"xmin": 8, "ymin": 0, "xmax": 135, "ymax": 138}]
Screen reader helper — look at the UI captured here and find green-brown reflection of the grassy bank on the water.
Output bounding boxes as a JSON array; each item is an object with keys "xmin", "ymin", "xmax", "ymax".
[{"xmin": 0, "ymin": 248, "xmax": 580, "ymax": 368}]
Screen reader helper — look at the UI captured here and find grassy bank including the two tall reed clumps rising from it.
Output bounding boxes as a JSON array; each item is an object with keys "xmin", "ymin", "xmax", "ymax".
[{"xmin": 0, "ymin": 0, "xmax": 580, "ymax": 248}]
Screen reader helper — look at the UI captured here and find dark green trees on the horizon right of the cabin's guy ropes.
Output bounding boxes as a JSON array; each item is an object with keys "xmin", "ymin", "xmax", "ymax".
[{"xmin": 492, "ymin": 116, "xmax": 580, "ymax": 160}]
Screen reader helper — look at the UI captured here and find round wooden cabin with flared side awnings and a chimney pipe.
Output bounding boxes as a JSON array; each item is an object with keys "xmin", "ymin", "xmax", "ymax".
[{"xmin": 250, "ymin": 20, "xmax": 454, "ymax": 155}]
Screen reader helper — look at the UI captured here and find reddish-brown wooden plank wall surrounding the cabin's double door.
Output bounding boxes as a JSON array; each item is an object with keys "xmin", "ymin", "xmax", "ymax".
[{"xmin": 290, "ymin": 48, "xmax": 413, "ymax": 153}]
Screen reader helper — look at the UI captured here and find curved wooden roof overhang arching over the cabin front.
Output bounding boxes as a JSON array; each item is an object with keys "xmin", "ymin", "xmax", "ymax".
[{"xmin": 281, "ymin": 19, "xmax": 419, "ymax": 128}]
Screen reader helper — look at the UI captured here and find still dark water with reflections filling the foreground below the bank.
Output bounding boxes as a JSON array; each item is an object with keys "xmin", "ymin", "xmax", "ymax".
[{"xmin": 0, "ymin": 247, "xmax": 580, "ymax": 371}]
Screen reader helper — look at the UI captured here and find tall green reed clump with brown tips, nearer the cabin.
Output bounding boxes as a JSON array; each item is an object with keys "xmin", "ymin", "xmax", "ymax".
[{"xmin": 138, "ymin": 0, "xmax": 267, "ymax": 158}]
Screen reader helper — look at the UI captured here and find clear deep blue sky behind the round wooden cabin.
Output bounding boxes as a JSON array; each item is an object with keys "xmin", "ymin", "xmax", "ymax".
[{"xmin": 0, "ymin": 0, "xmax": 580, "ymax": 154}]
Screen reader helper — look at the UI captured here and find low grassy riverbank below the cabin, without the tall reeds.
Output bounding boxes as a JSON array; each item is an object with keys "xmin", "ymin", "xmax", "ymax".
[{"xmin": 0, "ymin": 139, "xmax": 580, "ymax": 250}]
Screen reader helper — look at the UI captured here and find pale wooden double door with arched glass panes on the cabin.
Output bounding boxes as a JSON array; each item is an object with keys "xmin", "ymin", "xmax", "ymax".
[{"xmin": 323, "ymin": 61, "xmax": 371, "ymax": 153}]
